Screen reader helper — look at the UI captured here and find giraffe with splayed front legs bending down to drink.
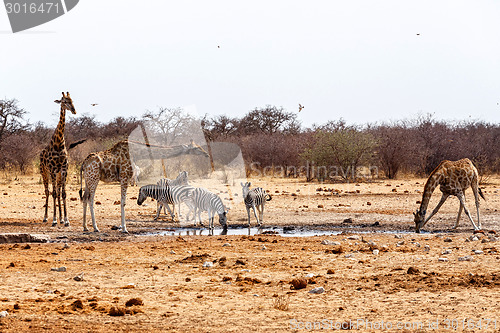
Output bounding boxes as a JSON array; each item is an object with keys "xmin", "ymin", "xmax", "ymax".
[{"xmin": 413, "ymin": 158, "xmax": 486, "ymax": 233}]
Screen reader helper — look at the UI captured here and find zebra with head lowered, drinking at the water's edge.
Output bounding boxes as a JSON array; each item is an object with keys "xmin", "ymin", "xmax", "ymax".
[{"xmin": 186, "ymin": 187, "xmax": 229, "ymax": 234}]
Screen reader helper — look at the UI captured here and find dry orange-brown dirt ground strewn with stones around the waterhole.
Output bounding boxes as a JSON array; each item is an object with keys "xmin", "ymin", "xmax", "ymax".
[{"xmin": 0, "ymin": 175, "xmax": 500, "ymax": 332}]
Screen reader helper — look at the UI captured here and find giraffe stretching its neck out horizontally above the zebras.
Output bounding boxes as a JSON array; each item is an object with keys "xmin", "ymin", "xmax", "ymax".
[{"xmin": 80, "ymin": 140, "xmax": 208, "ymax": 233}]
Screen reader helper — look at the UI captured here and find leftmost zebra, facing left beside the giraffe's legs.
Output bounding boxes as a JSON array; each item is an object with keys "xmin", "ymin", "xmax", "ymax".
[{"xmin": 137, "ymin": 184, "xmax": 194, "ymax": 221}]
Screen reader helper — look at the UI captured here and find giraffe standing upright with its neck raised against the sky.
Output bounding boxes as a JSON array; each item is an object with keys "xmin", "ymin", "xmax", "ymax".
[{"xmin": 40, "ymin": 92, "xmax": 76, "ymax": 226}]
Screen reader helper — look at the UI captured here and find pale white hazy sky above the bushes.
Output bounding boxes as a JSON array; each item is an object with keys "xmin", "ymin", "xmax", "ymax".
[{"xmin": 0, "ymin": 0, "xmax": 500, "ymax": 126}]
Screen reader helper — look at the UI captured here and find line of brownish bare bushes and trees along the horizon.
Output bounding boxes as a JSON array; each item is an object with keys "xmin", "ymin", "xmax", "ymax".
[{"xmin": 0, "ymin": 100, "xmax": 500, "ymax": 181}]
